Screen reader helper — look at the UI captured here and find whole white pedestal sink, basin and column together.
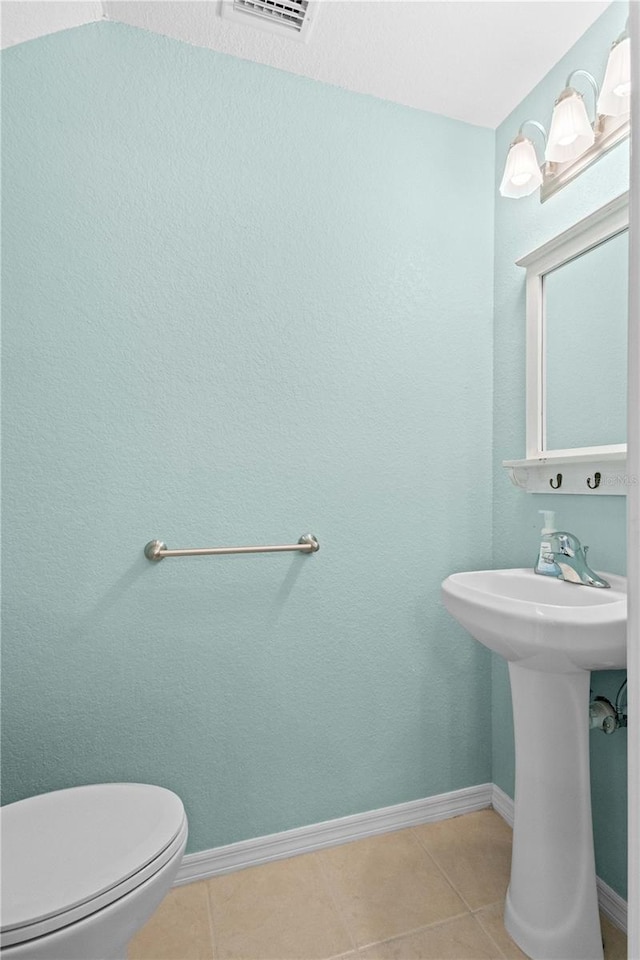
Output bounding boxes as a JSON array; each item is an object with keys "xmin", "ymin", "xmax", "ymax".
[{"xmin": 442, "ymin": 570, "xmax": 627, "ymax": 960}]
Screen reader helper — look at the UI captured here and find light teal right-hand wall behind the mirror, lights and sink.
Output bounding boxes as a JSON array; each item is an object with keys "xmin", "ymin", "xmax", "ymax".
[{"xmin": 492, "ymin": 3, "xmax": 629, "ymax": 896}]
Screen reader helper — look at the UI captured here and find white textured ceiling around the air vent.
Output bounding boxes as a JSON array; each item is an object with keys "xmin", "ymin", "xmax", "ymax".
[{"xmin": 0, "ymin": 0, "xmax": 612, "ymax": 128}]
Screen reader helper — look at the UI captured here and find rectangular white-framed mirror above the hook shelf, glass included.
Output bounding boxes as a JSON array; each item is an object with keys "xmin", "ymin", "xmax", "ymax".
[{"xmin": 517, "ymin": 193, "xmax": 629, "ymax": 461}]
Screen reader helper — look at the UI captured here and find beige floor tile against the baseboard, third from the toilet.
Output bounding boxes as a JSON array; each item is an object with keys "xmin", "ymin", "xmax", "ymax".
[{"xmin": 318, "ymin": 830, "xmax": 466, "ymax": 946}]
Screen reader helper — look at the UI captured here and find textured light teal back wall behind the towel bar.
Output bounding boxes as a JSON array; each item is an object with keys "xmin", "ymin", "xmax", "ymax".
[{"xmin": 3, "ymin": 23, "xmax": 496, "ymax": 851}]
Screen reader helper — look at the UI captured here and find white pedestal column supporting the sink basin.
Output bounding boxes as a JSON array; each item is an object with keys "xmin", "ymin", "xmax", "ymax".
[{"xmin": 505, "ymin": 663, "xmax": 603, "ymax": 960}]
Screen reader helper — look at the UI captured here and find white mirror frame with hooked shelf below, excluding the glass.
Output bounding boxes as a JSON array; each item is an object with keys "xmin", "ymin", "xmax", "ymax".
[{"xmin": 503, "ymin": 191, "xmax": 629, "ymax": 495}]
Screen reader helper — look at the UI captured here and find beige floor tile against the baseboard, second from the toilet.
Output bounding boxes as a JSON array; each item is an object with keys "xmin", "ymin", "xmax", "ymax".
[{"xmin": 208, "ymin": 853, "xmax": 354, "ymax": 960}]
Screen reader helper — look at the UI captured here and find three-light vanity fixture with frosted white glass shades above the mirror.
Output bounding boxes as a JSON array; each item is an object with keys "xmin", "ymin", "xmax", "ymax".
[{"xmin": 500, "ymin": 21, "xmax": 631, "ymax": 201}]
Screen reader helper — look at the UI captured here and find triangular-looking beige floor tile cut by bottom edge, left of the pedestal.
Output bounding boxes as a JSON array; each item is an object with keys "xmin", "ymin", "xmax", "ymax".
[{"xmin": 360, "ymin": 914, "xmax": 502, "ymax": 960}]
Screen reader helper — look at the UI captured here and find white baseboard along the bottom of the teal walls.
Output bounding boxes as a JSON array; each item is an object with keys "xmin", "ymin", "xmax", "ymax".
[{"xmin": 174, "ymin": 783, "xmax": 627, "ymax": 933}]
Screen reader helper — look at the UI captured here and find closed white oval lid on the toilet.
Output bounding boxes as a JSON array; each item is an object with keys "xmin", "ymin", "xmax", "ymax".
[{"xmin": 1, "ymin": 783, "xmax": 185, "ymax": 932}]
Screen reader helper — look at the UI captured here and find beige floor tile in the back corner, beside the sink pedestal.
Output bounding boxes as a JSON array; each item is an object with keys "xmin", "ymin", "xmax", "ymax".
[{"xmin": 413, "ymin": 810, "xmax": 511, "ymax": 910}]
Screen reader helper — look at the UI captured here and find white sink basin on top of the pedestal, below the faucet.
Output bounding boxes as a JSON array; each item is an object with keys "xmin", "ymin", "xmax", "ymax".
[{"xmin": 442, "ymin": 569, "xmax": 627, "ymax": 673}]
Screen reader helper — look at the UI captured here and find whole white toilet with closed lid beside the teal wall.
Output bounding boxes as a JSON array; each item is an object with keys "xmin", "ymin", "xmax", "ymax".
[{"xmin": 0, "ymin": 783, "xmax": 188, "ymax": 960}]
